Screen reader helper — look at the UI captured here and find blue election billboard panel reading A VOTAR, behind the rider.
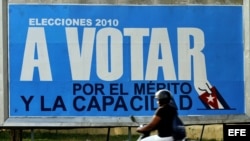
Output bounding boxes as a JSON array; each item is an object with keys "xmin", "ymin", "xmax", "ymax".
[{"xmin": 8, "ymin": 4, "xmax": 245, "ymax": 117}]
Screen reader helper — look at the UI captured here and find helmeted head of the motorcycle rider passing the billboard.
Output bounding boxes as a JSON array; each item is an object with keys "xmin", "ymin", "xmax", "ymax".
[{"xmin": 155, "ymin": 89, "xmax": 172, "ymax": 106}]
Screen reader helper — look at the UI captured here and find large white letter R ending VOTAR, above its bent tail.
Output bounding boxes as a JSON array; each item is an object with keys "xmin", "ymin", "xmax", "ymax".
[{"xmin": 178, "ymin": 28, "xmax": 207, "ymax": 81}]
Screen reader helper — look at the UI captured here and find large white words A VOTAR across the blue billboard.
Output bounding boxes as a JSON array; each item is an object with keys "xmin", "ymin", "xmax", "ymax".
[{"xmin": 21, "ymin": 27, "xmax": 207, "ymax": 81}]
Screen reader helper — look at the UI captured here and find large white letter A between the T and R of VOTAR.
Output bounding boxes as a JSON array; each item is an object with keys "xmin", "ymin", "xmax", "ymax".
[{"xmin": 145, "ymin": 28, "xmax": 176, "ymax": 80}]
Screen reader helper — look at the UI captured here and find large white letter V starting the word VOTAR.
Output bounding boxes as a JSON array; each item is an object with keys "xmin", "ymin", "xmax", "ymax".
[{"xmin": 66, "ymin": 27, "xmax": 95, "ymax": 80}]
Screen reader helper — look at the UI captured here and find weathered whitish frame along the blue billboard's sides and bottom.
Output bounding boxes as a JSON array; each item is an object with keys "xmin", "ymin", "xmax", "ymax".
[{"xmin": 0, "ymin": 0, "xmax": 250, "ymax": 127}]
